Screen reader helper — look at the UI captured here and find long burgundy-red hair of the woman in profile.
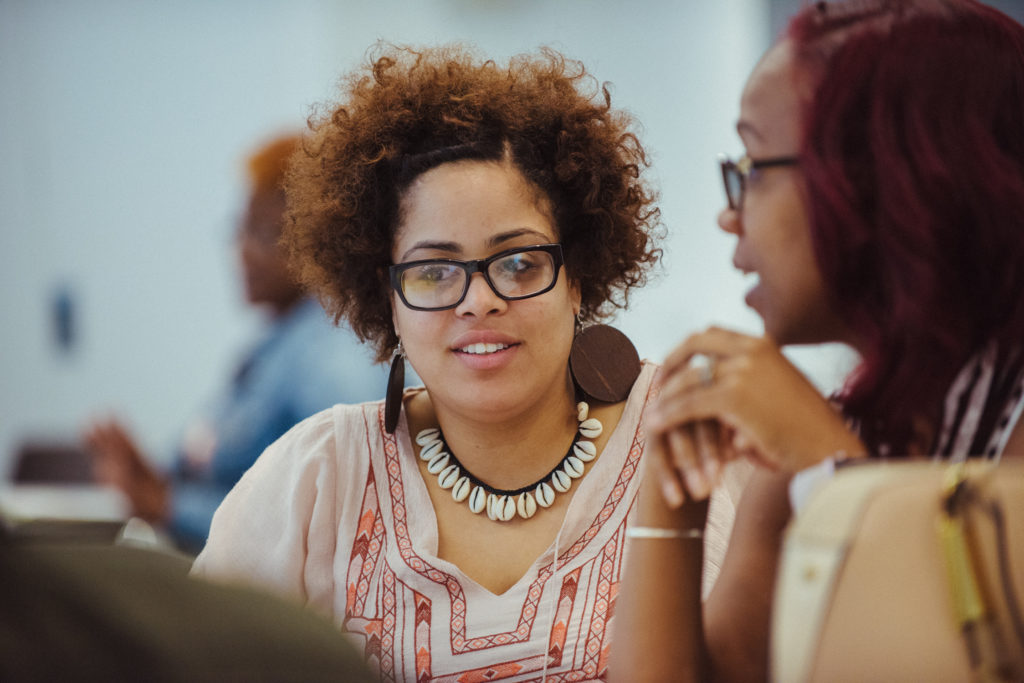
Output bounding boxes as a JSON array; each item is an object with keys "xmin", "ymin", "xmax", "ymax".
[{"xmin": 786, "ymin": 0, "xmax": 1024, "ymax": 454}]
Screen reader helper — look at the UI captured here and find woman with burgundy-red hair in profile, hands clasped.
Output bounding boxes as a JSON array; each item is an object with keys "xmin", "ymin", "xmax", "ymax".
[{"xmin": 612, "ymin": 0, "xmax": 1024, "ymax": 681}]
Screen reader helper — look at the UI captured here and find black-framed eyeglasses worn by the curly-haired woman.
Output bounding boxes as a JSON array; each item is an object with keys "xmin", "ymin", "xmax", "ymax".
[{"xmin": 388, "ymin": 244, "xmax": 564, "ymax": 310}]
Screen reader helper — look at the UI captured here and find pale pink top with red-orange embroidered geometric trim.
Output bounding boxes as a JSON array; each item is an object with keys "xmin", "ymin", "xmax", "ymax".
[{"xmin": 194, "ymin": 364, "xmax": 734, "ymax": 681}]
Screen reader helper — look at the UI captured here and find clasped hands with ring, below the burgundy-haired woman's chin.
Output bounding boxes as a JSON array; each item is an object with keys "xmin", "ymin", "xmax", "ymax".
[{"xmin": 645, "ymin": 328, "xmax": 864, "ymax": 505}]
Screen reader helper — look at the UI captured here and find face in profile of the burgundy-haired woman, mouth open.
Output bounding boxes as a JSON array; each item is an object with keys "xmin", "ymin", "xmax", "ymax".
[{"xmin": 718, "ymin": 41, "xmax": 849, "ymax": 344}]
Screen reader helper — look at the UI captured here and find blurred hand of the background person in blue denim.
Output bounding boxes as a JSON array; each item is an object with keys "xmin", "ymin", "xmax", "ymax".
[{"xmin": 84, "ymin": 419, "xmax": 170, "ymax": 522}]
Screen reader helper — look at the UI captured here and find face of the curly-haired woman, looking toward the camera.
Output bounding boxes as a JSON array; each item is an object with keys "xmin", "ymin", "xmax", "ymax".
[{"xmin": 391, "ymin": 161, "xmax": 580, "ymax": 420}]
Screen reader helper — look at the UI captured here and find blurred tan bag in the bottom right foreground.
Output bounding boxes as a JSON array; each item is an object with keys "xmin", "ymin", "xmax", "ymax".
[{"xmin": 771, "ymin": 462, "xmax": 1024, "ymax": 683}]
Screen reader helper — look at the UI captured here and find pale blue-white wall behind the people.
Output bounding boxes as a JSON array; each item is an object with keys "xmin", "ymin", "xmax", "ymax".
[{"xmin": 0, "ymin": 0, "xmax": 847, "ymax": 473}]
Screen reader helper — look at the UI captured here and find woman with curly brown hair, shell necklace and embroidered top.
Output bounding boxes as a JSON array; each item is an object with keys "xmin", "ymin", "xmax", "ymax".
[{"xmin": 196, "ymin": 46, "xmax": 737, "ymax": 681}]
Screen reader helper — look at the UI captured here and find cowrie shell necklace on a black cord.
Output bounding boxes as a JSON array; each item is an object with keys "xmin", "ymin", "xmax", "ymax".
[{"xmin": 416, "ymin": 401, "xmax": 604, "ymax": 522}]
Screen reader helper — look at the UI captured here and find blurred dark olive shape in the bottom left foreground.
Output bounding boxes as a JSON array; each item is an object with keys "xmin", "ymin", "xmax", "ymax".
[{"xmin": 0, "ymin": 520, "xmax": 372, "ymax": 682}]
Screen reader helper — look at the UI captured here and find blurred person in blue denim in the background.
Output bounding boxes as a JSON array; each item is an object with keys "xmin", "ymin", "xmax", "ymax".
[{"xmin": 85, "ymin": 135, "xmax": 385, "ymax": 552}]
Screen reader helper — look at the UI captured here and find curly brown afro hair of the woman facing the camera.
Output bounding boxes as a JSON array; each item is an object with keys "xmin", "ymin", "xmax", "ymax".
[{"xmin": 284, "ymin": 44, "xmax": 664, "ymax": 360}]
